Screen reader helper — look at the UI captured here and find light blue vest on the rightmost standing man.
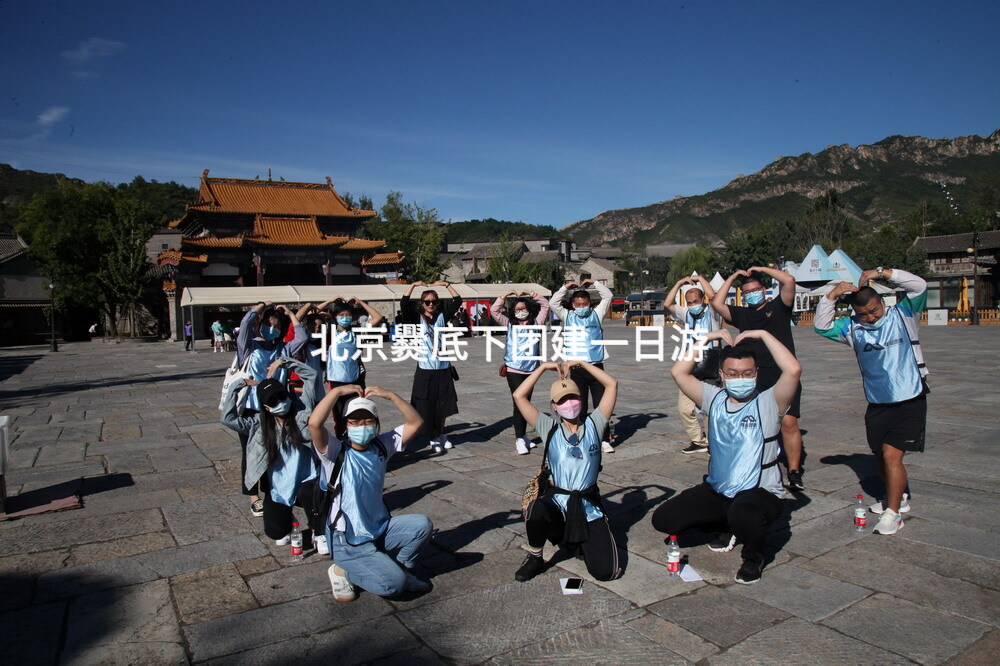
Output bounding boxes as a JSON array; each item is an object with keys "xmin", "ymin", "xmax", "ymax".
[{"xmin": 850, "ymin": 307, "xmax": 924, "ymax": 404}]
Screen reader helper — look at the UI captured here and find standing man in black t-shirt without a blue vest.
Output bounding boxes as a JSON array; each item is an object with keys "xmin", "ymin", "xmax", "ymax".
[{"xmin": 712, "ymin": 266, "xmax": 805, "ymax": 490}]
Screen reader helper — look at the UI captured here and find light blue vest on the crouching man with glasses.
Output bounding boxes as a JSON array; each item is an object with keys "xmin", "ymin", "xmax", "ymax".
[{"xmin": 705, "ymin": 391, "xmax": 778, "ymax": 497}]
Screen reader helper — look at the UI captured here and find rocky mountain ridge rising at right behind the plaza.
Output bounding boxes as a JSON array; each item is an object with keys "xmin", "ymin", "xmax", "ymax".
[{"xmin": 561, "ymin": 129, "xmax": 1000, "ymax": 247}]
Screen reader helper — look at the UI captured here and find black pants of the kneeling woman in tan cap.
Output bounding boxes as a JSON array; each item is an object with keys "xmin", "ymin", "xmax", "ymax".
[{"xmin": 524, "ymin": 497, "xmax": 621, "ymax": 580}]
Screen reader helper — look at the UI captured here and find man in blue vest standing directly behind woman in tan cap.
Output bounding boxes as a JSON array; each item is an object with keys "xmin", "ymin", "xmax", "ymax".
[{"xmin": 549, "ymin": 279, "xmax": 615, "ymax": 453}]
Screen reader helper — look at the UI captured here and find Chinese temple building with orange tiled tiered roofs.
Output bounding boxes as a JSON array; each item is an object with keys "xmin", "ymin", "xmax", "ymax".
[{"xmin": 148, "ymin": 169, "xmax": 403, "ymax": 337}]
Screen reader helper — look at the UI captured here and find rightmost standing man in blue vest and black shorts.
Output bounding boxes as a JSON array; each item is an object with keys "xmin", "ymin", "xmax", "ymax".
[{"xmin": 814, "ymin": 267, "xmax": 930, "ymax": 534}]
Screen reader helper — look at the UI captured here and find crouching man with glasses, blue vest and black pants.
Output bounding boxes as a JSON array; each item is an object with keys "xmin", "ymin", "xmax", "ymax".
[{"xmin": 653, "ymin": 329, "xmax": 802, "ymax": 585}]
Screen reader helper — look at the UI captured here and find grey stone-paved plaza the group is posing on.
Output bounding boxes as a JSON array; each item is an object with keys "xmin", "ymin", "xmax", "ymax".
[{"xmin": 0, "ymin": 321, "xmax": 1000, "ymax": 665}]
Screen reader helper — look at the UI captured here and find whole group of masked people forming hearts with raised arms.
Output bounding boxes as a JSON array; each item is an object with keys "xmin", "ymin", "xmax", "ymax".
[{"xmin": 222, "ymin": 266, "xmax": 928, "ymax": 601}]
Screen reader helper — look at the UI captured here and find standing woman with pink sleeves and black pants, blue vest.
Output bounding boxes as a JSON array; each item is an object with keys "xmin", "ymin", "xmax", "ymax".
[{"xmin": 490, "ymin": 291, "xmax": 549, "ymax": 455}]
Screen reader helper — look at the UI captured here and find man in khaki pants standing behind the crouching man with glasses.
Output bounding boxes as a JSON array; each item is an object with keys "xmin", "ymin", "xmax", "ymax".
[{"xmin": 663, "ymin": 275, "xmax": 722, "ymax": 453}]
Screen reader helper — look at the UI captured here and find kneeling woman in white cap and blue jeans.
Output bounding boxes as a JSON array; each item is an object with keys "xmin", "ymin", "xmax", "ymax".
[{"xmin": 309, "ymin": 384, "xmax": 433, "ymax": 601}]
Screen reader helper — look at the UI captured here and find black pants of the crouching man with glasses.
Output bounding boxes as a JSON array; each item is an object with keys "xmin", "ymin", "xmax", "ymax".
[{"xmin": 653, "ymin": 483, "xmax": 782, "ymax": 562}]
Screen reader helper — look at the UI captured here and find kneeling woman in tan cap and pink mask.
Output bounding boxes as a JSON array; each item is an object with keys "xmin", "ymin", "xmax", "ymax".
[{"xmin": 514, "ymin": 361, "xmax": 622, "ymax": 582}]
